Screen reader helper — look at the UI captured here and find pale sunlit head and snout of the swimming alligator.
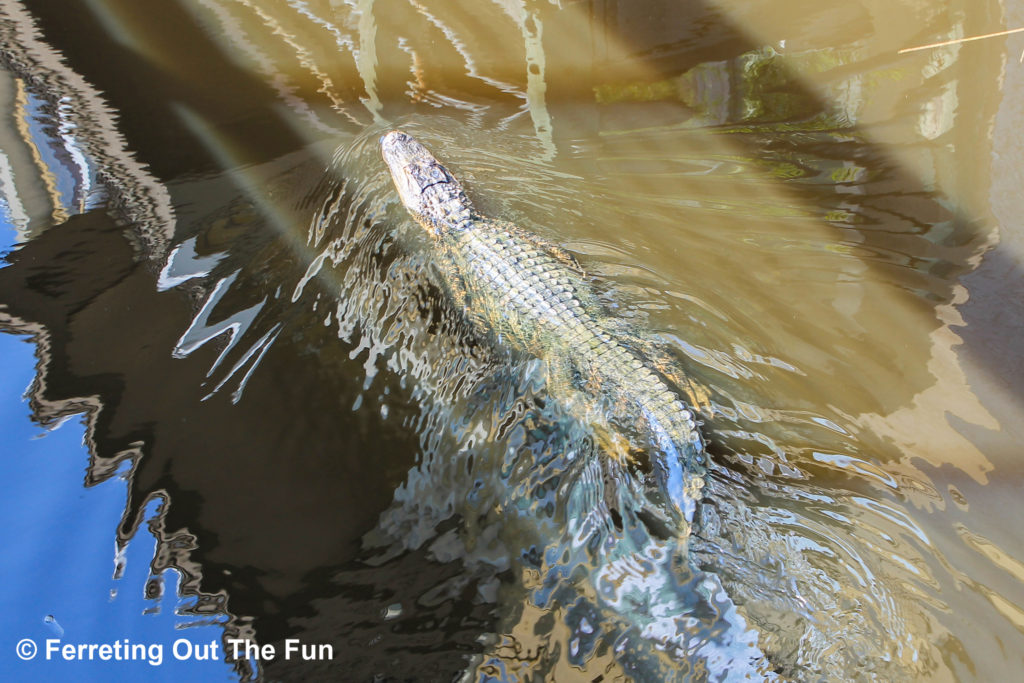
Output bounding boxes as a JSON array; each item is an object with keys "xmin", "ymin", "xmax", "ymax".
[{"xmin": 380, "ymin": 130, "xmax": 462, "ymax": 229}]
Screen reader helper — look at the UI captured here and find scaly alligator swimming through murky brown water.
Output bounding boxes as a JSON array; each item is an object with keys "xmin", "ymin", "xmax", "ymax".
[{"xmin": 381, "ymin": 131, "xmax": 703, "ymax": 522}]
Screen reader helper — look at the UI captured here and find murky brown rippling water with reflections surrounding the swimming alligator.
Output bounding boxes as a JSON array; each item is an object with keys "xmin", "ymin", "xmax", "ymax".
[{"xmin": 0, "ymin": 0, "xmax": 1024, "ymax": 681}]
